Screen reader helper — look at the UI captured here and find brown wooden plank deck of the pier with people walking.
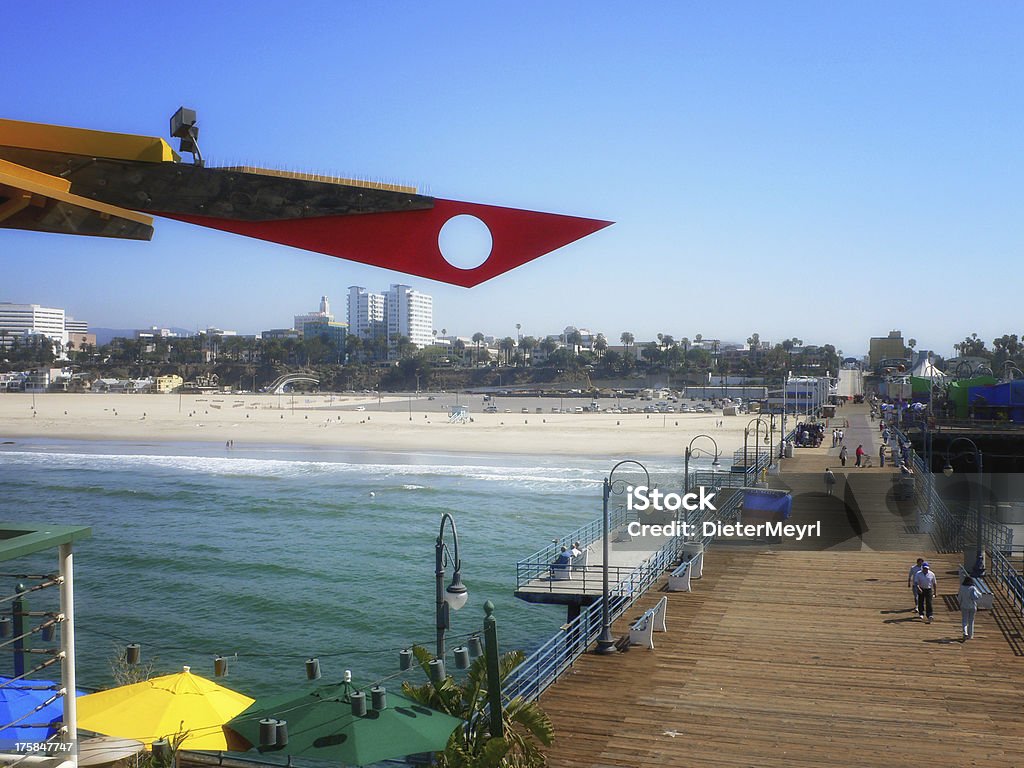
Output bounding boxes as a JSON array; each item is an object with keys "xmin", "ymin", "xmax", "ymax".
[{"xmin": 541, "ymin": 407, "xmax": 1024, "ymax": 768}]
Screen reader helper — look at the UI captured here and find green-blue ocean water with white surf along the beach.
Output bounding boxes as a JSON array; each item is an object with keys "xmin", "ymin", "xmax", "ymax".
[{"xmin": 0, "ymin": 440, "xmax": 681, "ymax": 696}]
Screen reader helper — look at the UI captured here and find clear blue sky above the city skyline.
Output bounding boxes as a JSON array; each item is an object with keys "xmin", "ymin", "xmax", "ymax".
[{"xmin": 0, "ymin": 0, "xmax": 1024, "ymax": 354}]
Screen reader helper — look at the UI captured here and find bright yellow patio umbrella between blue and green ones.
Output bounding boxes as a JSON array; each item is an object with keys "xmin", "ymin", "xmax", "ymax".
[{"xmin": 78, "ymin": 667, "xmax": 255, "ymax": 750}]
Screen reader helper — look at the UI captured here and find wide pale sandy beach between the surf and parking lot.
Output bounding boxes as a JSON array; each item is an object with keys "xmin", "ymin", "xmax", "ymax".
[{"xmin": 0, "ymin": 393, "xmax": 777, "ymax": 463}]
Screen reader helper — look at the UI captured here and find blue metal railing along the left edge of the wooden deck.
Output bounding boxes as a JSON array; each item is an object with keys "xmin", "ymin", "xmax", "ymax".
[{"xmin": 502, "ymin": 494, "xmax": 742, "ymax": 700}]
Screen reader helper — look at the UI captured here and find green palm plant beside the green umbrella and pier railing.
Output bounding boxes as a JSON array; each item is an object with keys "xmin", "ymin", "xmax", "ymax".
[{"xmin": 401, "ymin": 646, "xmax": 554, "ymax": 768}]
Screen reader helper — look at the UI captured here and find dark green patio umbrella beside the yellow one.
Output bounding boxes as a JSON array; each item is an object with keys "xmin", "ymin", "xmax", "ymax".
[{"xmin": 225, "ymin": 683, "xmax": 463, "ymax": 765}]
